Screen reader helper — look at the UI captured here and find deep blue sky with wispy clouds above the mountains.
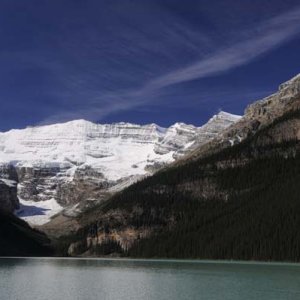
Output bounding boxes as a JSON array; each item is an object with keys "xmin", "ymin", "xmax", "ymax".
[{"xmin": 0, "ymin": 0, "xmax": 300, "ymax": 131}]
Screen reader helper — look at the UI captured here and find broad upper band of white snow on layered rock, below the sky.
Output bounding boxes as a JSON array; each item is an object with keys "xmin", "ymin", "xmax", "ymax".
[{"xmin": 0, "ymin": 112, "xmax": 239, "ymax": 180}]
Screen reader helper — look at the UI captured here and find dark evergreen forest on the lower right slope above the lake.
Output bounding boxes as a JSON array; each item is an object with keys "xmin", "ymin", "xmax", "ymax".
[{"xmin": 128, "ymin": 157, "xmax": 300, "ymax": 261}]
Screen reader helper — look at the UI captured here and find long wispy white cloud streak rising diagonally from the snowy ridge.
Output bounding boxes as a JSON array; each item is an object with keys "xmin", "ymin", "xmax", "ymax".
[{"xmin": 43, "ymin": 7, "xmax": 300, "ymax": 123}]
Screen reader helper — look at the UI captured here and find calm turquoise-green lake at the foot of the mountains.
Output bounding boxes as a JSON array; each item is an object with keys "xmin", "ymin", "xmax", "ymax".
[{"xmin": 0, "ymin": 258, "xmax": 300, "ymax": 300}]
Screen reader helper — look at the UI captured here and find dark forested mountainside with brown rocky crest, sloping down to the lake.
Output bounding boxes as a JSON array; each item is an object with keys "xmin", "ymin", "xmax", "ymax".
[{"xmin": 61, "ymin": 75, "xmax": 300, "ymax": 261}]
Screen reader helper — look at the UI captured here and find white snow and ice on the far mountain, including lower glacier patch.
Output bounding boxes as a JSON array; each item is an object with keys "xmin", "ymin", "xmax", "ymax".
[{"xmin": 0, "ymin": 112, "xmax": 240, "ymax": 225}]
